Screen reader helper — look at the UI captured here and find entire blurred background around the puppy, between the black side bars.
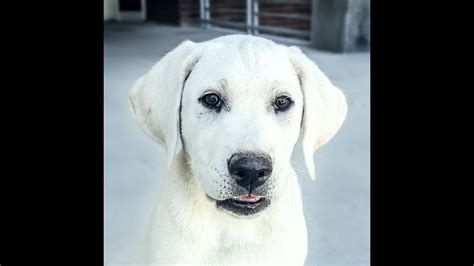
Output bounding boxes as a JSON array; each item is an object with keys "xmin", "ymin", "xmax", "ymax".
[{"xmin": 104, "ymin": 0, "xmax": 370, "ymax": 265}]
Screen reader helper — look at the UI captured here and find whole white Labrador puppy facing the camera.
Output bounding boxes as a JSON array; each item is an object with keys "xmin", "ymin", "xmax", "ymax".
[{"xmin": 129, "ymin": 35, "xmax": 347, "ymax": 265}]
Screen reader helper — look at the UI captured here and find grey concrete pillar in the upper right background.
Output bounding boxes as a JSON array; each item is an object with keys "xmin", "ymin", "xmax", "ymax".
[{"xmin": 311, "ymin": 0, "xmax": 370, "ymax": 53}]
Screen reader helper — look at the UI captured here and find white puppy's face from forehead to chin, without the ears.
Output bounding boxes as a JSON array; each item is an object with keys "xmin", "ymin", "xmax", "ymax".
[{"xmin": 181, "ymin": 42, "xmax": 303, "ymax": 215}]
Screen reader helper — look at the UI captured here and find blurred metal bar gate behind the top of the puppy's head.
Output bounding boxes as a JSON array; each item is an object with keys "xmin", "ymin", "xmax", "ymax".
[{"xmin": 199, "ymin": 0, "xmax": 311, "ymax": 40}]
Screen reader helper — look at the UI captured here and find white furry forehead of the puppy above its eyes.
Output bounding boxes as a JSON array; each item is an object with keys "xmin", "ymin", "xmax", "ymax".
[{"xmin": 190, "ymin": 35, "xmax": 299, "ymax": 96}]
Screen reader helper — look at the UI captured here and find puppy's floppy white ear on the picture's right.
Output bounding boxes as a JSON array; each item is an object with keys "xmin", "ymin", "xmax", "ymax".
[{"xmin": 289, "ymin": 46, "xmax": 347, "ymax": 180}]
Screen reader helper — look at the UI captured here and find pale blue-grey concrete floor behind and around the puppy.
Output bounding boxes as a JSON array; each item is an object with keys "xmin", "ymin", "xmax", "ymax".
[{"xmin": 104, "ymin": 23, "xmax": 370, "ymax": 265}]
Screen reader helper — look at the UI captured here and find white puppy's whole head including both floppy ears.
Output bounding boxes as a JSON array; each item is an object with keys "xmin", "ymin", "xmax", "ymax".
[{"xmin": 129, "ymin": 35, "xmax": 347, "ymax": 216}]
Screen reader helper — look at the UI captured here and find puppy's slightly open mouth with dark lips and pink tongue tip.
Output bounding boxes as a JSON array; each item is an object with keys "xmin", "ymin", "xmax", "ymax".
[{"xmin": 216, "ymin": 195, "xmax": 270, "ymax": 216}]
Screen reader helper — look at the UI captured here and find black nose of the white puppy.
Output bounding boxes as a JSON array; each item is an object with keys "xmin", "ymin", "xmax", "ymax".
[{"xmin": 228, "ymin": 153, "xmax": 272, "ymax": 193}]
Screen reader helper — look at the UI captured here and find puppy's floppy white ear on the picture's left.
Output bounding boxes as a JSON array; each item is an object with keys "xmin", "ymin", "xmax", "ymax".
[{"xmin": 128, "ymin": 41, "xmax": 198, "ymax": 168}]
